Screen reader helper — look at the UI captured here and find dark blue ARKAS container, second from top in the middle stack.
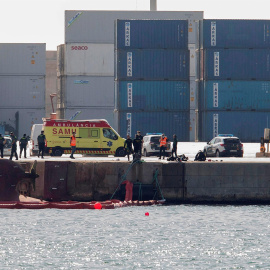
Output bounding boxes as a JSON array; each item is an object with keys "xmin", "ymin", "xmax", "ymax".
[{"xmin": 116, "ymin": 50, "xmax": 189, "ymax": 80}]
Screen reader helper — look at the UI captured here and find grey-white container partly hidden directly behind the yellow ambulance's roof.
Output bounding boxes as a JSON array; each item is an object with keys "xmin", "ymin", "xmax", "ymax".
[{"xmin": 64, "ymin": 107, "xmax": 115, "ymax": 128}]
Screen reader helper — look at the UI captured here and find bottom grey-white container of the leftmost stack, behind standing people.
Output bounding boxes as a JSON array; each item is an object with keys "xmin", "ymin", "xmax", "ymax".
[{"xmin": 0, "ymin": 108, "xmax": 45, "ymax": 139}]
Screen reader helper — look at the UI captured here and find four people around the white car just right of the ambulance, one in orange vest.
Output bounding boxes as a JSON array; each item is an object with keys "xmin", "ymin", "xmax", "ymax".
[{"xmin": 124, "ymin": 131, "xmax": 178, "ymax": 161}]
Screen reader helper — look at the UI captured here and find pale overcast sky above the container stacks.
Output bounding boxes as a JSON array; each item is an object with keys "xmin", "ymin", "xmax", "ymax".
[{"xmin": 0, "ymin": 0, "xmax": 270, "ymax": 50}]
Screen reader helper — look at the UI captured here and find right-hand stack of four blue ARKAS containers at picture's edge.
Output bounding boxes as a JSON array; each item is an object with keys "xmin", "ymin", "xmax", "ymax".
[{"xmin": 199, "ymin": 20, "xmax": 270, "ymax": 142}]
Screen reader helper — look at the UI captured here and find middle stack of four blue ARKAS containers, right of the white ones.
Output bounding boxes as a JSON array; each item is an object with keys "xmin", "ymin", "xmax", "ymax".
[{"xmin": 115, "ymin": 20, "xmax": 190, "ymax": 141}]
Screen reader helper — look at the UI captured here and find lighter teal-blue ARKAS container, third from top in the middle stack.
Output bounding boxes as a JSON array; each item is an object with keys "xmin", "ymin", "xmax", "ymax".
[{"xmin": 116, "ymin": 81, "xmax": 190, "ymax": 111}]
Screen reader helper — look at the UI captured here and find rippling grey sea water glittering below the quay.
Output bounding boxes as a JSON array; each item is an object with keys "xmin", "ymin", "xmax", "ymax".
[{"xmin": 0, "ymin": 205, "xmax": 270, "ymax": 269}]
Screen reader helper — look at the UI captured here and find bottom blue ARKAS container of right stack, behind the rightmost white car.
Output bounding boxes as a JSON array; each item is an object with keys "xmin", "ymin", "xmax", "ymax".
[{"xmin": 200, "ymin": 111, "xmax": 270, "ymax": 142}]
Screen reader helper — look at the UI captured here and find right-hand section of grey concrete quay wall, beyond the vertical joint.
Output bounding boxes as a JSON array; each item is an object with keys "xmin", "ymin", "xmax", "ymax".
[{"xmin": 185, "ymin": 162, "xmax": 270, "ymax": 203}]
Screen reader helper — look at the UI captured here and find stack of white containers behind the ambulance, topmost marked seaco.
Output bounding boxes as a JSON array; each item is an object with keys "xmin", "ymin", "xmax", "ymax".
[{"xmin": 57, "ymin": 40, "xmax": 114, "ymax": 123}]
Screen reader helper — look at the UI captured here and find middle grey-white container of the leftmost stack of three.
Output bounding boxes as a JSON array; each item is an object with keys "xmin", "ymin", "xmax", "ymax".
[{"xmin": 0, "ymin": 76, "xmax": 45, "ymax": 109}]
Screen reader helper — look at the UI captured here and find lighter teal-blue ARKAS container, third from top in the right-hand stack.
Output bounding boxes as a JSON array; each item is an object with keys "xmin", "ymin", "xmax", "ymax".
[{"xmin": 199, "ymin": 80, "xmax": 270, "ymax": 111}]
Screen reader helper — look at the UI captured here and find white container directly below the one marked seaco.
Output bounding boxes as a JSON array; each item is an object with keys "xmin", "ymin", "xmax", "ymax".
[{"xmin": 58, "ymin": 76, "xmax": 114, "ymax": 107}]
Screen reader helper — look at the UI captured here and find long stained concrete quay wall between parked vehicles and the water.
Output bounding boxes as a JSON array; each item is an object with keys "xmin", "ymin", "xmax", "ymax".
[{"xmin": 15, "ymin": 160, "xmax": 270, "ymax": 204}]
